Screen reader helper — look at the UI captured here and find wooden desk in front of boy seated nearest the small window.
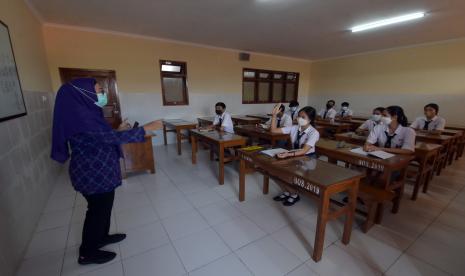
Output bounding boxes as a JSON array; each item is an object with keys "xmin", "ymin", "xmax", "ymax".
[{"xmin": 190, "ymin": 129, "xmax": 247, "ymax": 185}]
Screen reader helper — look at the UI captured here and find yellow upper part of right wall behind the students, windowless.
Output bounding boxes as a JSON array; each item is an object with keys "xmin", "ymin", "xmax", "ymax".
[{"xmin": 310, "ymin": 40, "xmax": 465, "ymax": 123}]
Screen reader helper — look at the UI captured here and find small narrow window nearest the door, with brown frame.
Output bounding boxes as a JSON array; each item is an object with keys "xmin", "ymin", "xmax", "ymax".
[{"xmin": 160, "ymin": 60, "xmax": 189, "ymax": 105}]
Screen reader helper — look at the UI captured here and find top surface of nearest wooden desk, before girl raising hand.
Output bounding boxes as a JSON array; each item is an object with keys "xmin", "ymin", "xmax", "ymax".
[{"xmin": 239, "ymin": 149, "xmax": 365, "ymax": 189}]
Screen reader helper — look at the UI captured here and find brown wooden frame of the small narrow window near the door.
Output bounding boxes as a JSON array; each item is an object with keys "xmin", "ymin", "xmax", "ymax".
[{"xmin": 159, "ymin": 59, "xmax": 189, "ymax": 106}]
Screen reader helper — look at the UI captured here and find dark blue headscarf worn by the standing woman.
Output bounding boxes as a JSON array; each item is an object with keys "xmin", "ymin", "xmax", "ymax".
[{"xmin": 51, "ymin": 78, "xmax": 112, "ymax": 163}]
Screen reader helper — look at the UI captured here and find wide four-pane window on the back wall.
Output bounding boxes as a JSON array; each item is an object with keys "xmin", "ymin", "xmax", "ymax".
[{"xmin": 242, "ymin": 68, "xmax": 299, "ymax": 104}]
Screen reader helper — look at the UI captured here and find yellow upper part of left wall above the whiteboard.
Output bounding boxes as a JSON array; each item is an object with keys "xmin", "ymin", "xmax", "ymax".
[{"xmin": 0, "ymin": 0, "xmax": 51, "ymax": 92}]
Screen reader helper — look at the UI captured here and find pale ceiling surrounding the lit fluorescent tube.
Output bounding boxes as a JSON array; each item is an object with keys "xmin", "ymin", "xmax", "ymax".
[{"xmin": 26, "ymin": 0, "xmax": 465, "ymax": 60}]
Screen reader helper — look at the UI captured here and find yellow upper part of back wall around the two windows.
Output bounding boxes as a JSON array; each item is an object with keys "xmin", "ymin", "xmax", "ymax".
[{"xmin": 44, "ymin": 26, "xmax": 310, "ymax": 97}]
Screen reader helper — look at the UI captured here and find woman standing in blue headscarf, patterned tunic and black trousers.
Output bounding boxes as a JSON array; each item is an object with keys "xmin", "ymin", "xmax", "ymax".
[{"xmin": 51, "ymin": 78, "xmax": 162, "ymax": 265}]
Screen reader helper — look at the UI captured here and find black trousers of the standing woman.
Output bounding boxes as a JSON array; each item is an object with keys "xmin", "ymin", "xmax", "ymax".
[{"xmin": 79, "ymin": 191, "xmax": 115, "ymax": 256}]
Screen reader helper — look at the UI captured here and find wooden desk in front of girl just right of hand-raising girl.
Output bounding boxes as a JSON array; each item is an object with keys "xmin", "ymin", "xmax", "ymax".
[{"xmin": 315, "ymin": 139, "xmax": 414, "ymax": 231}]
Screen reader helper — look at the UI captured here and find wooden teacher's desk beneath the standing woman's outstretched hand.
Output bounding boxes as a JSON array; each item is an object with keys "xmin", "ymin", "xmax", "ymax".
[{"xmin": 121, "ymin": 134, "xmax": 155, "ymax": 178}]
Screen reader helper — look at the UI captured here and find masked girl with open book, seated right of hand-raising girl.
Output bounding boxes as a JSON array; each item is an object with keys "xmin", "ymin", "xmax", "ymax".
[{"xmin": 364, "ymin": 106, "xmax": 416, "ymax": 154}]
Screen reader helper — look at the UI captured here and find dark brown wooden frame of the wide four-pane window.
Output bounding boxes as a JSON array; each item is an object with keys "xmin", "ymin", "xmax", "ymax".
[{"xmin": 242, "ymin": 68, "xmax": 300, "ymax": 104}]
